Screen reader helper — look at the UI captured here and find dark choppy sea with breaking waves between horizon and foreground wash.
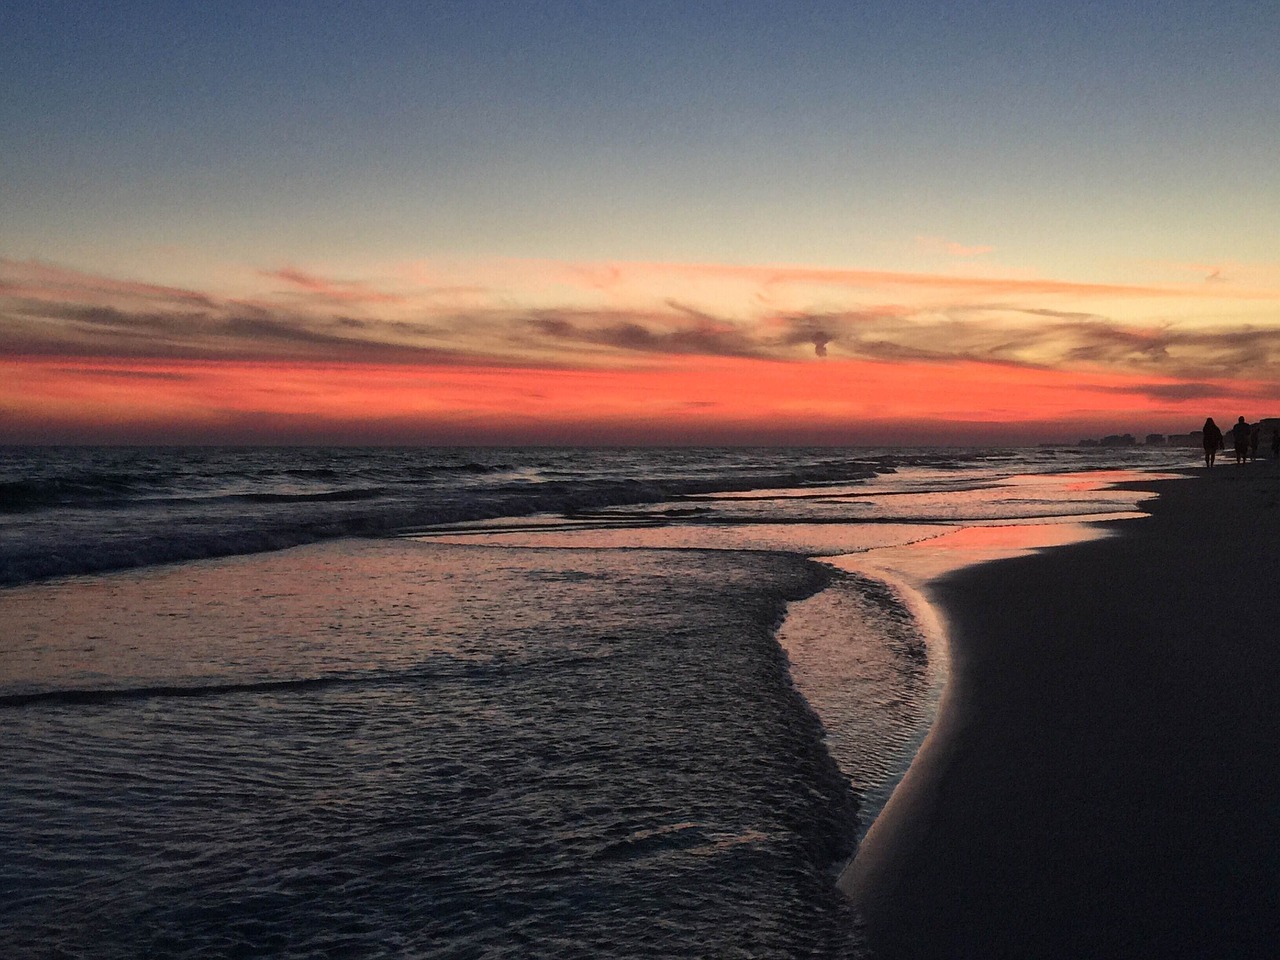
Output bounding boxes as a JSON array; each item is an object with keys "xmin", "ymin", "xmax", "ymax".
[{"xmin": 0, "ymin": 447, "xmax": 1187, "ymax": 586}]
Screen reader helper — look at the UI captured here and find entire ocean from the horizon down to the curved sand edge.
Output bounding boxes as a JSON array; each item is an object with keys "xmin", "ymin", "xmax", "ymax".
[{"xmin": 0, "ymin": 448, "xmax": 1196, "ymax": 957}]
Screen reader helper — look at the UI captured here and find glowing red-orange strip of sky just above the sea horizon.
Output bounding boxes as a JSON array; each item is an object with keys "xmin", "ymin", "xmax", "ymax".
[{"xmin": 0, "ymin": 356, "xmax": 1256, "ymax": 443}]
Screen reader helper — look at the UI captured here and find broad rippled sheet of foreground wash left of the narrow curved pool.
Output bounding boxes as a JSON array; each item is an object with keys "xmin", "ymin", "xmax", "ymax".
[{"xmin": 0, "ymin": 543, "xmax": 856, "ymax": 957}]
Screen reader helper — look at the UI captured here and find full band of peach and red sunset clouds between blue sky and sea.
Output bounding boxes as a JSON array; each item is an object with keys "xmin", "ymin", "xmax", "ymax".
[{"xmin": 0, "ymin": 260, "xmax": 1280, "ymax": 442}]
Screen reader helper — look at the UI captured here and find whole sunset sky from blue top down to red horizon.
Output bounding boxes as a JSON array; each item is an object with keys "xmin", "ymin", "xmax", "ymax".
[{"xmin": 0, "ymin": 0, "xmax": 1280, "ymax": 444}]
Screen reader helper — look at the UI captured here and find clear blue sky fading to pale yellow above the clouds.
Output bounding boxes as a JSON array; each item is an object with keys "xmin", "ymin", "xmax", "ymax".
[{"xmin": 10, "ymin": 3, "xmax": 1280, "ymax": 276}]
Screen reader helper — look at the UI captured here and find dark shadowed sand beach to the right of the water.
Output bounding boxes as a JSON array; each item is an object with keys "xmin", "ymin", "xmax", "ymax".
[{"xmin": 841, "ymin": 463, "xmax": 1280, "ymax": 960}]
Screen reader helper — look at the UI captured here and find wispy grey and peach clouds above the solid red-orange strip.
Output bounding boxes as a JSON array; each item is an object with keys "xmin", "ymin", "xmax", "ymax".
[{"xmin": 0, "ymin": 260, "xmax": 1280, "ymax": 399}]
